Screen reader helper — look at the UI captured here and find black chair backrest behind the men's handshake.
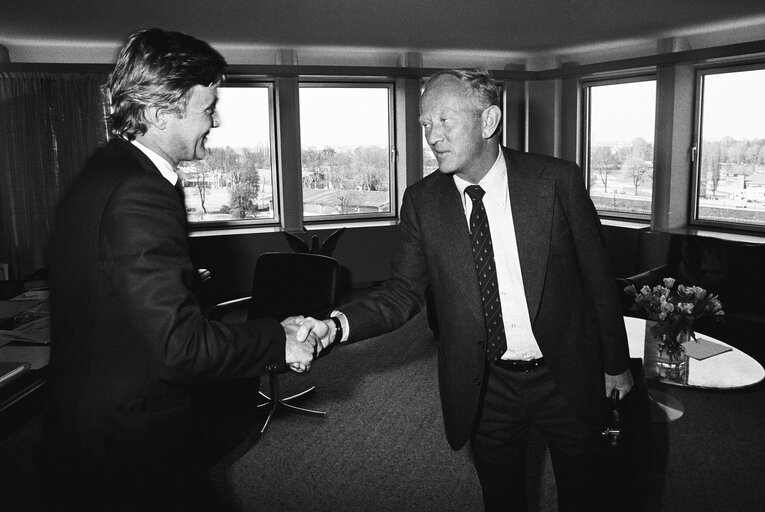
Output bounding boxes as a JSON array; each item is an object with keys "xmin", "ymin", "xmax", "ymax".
[{"xmin": 247, "ymin": 252, "xmax": 340, "ymax": 321}]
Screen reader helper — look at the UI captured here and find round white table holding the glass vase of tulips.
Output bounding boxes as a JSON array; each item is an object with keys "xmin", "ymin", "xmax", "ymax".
[{"xmin": 624, "ymin": 316, "xmax": 765, "ymax": 421}]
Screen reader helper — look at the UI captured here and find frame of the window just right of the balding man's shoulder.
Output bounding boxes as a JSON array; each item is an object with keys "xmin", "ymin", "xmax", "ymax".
[{"xmin": 579, "ymin": 73, "xmax": 659, "ymax": 223}]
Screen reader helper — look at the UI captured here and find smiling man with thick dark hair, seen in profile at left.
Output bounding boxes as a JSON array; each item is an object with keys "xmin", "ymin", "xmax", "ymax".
[{"xmin": 38, "ymin": 29, "xmax": 321, "ymax": 511}]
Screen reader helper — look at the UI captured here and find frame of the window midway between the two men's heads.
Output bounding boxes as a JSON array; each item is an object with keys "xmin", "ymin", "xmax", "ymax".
[{"xmin": 297, "ymin": 76, "xmax": 399, "ymax": 224}]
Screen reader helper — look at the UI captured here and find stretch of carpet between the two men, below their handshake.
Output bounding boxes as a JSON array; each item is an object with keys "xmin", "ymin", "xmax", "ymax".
[{"xmin": 206, "ymin": 310, "xmax": 482, "ymax": 512}]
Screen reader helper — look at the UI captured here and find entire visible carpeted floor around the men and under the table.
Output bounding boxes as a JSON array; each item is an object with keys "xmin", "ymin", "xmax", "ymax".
[{"xmin": 0, "ymin": 306, "xmax": 765, "ymax": 512}]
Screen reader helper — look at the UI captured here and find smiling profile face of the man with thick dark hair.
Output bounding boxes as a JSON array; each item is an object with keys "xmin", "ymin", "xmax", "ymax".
[{"xmin": 166, "ymin": 85, "xmax": 219, "ymax": 163}]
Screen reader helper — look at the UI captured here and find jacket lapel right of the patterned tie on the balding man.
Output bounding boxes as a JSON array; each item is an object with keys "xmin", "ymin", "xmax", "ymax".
[{"xmin": 505, "ymin": 149, "xmax": 555, "ymax": 323}]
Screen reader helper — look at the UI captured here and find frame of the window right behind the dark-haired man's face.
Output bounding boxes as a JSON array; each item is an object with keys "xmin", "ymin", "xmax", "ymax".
[{"xmin": 188, "ymin": 79, "xmax": 282, "ymax": 231}]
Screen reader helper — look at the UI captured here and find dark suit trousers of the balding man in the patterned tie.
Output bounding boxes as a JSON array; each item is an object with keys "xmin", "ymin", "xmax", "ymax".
[{"xmin": 471, "ymin": 363, "xmax": 597, "ymax": 512}]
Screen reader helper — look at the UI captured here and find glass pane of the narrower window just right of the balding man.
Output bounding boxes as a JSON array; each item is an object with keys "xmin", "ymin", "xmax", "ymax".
[{"xmin": 586, "ymin": 80, "xmax": 656, "ymax": 216}]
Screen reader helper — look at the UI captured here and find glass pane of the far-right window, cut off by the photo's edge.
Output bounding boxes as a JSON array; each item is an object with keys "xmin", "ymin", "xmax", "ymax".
[{"xmin": 697, "ymin": 69, "xmax": 765, "ymax": 226}]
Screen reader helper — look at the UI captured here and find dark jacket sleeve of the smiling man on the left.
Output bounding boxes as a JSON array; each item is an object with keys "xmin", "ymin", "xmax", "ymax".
[{"xmin": 100, "ymin": 174, "xmax": 286, "ymax": 382}]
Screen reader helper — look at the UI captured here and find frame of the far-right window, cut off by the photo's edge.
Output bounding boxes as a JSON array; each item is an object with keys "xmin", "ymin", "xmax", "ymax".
[{"xmin": 688, "ymin": 57, "xmax": 765, "ymax": 234}]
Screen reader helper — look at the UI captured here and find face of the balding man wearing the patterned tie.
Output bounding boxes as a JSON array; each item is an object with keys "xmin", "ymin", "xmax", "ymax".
[{"xmin": 420, "ymin": 76, "xmax": 486, "ymax": 182}]
